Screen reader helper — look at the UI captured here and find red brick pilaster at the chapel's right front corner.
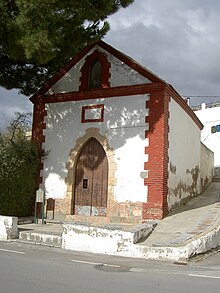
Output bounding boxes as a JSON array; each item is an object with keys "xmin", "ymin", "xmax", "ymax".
[{"xmin": 143, "ymin": 91, "xmax": 169, "ymax": 220}]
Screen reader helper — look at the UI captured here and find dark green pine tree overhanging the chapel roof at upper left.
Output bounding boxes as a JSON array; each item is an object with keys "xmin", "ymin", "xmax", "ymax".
[{"xmin": 0, "ymin": 0, "xmax": 134, "ymax": 95}]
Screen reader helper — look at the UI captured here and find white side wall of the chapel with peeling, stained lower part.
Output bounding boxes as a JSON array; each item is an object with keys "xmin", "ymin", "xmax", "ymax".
[{"xmin": 168, "ymin": 98, "xmax": 200, "ymax": 209}]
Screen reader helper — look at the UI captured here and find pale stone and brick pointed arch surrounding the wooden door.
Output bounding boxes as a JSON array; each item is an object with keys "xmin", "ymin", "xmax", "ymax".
[{"xmin": 65, "ymin": 127, "xmax": 116, "ymax": 217}]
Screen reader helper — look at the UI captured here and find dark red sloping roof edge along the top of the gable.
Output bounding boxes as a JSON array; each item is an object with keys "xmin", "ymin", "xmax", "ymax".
[{"xmin": 30, "ymin": 41, "xmax": 166, "ymax": 101}]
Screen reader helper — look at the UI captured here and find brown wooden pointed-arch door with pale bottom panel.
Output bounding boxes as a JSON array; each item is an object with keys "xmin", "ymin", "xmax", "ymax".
[{"xmin": 74, "ymin": 138, "xmax": 108, "ymax": 216}]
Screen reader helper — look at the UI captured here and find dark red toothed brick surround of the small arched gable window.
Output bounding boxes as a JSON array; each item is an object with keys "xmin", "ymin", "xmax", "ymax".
[{"xmin": 79, "ymin": 50, "xmax": 111, "ymax": 91}]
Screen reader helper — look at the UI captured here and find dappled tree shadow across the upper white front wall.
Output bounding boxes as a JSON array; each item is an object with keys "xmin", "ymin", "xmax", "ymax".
[{"xmin": 44, "ymin": 96, "xmax": 163, "ymax": 178}]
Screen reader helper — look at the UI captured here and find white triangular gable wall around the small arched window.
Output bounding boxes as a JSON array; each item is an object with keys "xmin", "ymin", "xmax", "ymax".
[{"xmin": 48, "ymin": 46, "xmax": 150, "ymax": 94}]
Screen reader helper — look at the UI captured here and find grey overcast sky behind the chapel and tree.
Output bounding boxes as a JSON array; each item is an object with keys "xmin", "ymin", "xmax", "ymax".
[{"xmin": 0, "ymin": 0, "xmax": 220, "ymax": 129}]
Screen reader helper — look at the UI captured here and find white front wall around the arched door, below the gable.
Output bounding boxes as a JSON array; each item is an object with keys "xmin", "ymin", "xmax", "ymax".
[{"xmin": 41, "ymin": 95, "xmax": 147, "ymax": 202}]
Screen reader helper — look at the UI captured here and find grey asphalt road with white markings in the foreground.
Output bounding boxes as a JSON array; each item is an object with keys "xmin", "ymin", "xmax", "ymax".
[{"xmin": 0, "ymin": 242, "xmax": 220, "ymax": 293}]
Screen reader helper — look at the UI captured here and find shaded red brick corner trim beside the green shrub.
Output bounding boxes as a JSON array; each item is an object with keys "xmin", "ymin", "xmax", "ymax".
[{"xmin": 32, "ymin": 96, "xmax": 47, "ymax": 186}]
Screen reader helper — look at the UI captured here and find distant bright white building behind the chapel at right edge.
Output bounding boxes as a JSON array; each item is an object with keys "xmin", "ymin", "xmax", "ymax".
[{"xmin": 195, "ymin": 104, "xmax": 220, "ymax": 167}]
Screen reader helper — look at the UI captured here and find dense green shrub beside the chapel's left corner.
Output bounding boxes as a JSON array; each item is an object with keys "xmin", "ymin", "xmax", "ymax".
[{"xmin": 0, "ymin": 112, "xmax": 39, "ymax": 217}]
